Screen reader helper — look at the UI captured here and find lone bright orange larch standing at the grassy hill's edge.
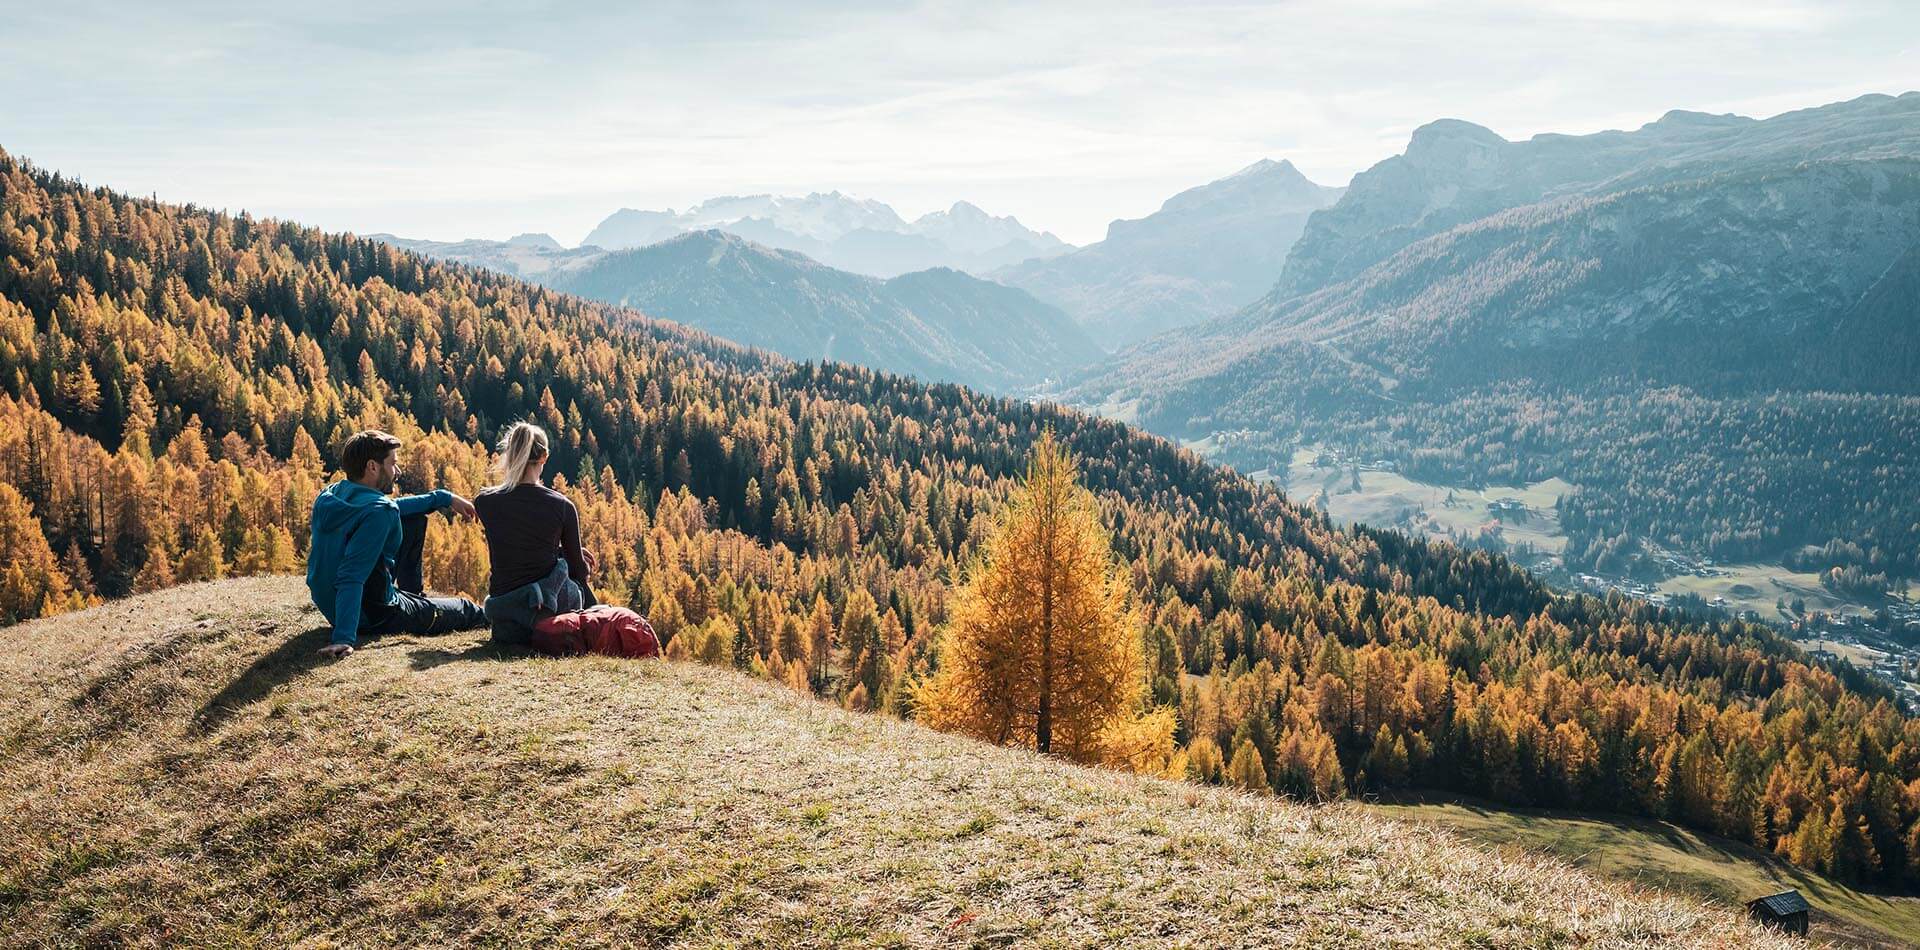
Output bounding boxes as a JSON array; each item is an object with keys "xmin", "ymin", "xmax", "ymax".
[{"xmin": 916, "ymin": 430, "xmax": 1173, "ymax": 772}]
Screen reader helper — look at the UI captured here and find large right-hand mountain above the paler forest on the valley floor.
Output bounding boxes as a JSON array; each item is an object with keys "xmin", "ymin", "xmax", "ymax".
[{"xmin": 1077, "ymin": 94, "xmax": 1920, "ymax": 412}]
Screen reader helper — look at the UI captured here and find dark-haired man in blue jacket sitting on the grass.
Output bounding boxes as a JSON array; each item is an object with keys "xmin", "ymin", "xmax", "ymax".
[{"xmin": 307, "ymin": 430, "xmax": 488, "ymax": 656}]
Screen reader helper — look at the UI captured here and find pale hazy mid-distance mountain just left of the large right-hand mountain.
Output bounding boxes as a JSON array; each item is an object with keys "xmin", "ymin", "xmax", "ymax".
[{"xmin": 989, "ymin": 159, "xmax": 1344, "ymax": 345}]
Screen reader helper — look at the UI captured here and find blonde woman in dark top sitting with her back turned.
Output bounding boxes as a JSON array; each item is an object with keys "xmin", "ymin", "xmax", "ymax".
[{"xmin": 474, "ymin": 422, "xmax": 593, "ymax": 647}]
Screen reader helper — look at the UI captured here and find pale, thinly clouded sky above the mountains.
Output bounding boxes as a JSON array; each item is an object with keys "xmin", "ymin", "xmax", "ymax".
[{"xmin": 0, "ymin": 0, "xmax": 1920, "ymax": 244}]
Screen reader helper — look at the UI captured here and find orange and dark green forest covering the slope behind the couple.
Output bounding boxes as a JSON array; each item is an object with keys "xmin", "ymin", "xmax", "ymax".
[{"xmin": 11, "ymin": 146, "xmax": 1920, "ymax": 883}]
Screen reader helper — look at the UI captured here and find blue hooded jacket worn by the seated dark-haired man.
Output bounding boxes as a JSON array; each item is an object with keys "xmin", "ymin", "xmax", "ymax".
[{"xmin": 307, "ymin": 480, "xmax": 453, "ymax": 647}]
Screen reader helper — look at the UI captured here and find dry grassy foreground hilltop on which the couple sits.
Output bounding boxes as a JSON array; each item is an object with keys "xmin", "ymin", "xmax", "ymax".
[{"xmin": 0, "ymin": 578, "xmax": 1793, "ymax": 946}]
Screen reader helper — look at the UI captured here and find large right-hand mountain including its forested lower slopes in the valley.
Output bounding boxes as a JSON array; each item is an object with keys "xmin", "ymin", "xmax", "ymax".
[{"xmin": 1066, "ymin": 94, "xmax": 1920, "ymax": 583}]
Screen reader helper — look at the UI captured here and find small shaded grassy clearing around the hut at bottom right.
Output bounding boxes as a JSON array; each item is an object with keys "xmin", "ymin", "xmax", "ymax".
[{"xmin": 1375, "ymin": 798, "xmax": 1920, "ymax": 946}]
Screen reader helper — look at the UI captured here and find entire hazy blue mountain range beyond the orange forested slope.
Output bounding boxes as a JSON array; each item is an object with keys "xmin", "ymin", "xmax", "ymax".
[{"xmin": 378, "ymin": 94, "xmax": 1920, "ymax": 583}]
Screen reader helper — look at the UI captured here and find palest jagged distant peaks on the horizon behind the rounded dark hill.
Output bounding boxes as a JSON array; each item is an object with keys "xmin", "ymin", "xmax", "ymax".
[{"xmin": 582, "ymin": 192, "xmax": 1073, "ymax": 276}]
